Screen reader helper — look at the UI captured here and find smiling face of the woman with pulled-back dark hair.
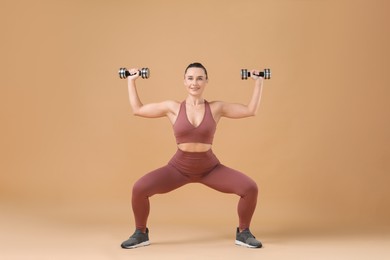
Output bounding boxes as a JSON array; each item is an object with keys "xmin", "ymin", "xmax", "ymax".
[{"xmin": 184, "ymin": 68, "xmax": 208, "ymax": 96}]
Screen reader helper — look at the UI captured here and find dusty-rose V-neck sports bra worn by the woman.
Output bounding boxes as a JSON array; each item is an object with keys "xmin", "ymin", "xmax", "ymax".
[{"xmin": 173, "ymin": 100, "xmax": 217, "ymax": 144}]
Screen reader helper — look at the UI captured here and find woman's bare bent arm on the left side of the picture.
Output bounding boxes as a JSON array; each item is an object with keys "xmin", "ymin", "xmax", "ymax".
[{"xmin": 128, "ymin": 69, "xmax": 178, "ymax": 121}]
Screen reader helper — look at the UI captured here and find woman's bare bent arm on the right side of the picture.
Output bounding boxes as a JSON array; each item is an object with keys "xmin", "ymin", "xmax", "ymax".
[{"xmin": 219, "ymin": 70, "xmax": 264, "ymax": 118}]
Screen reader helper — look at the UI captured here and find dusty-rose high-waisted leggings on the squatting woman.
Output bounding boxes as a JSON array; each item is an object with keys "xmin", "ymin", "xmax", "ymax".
[{"xmin": 132, "ymin": 149, "xmax": 258, "ymax": 230}]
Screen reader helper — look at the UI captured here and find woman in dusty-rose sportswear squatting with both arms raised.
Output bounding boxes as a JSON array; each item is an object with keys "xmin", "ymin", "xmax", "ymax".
[{"xmin": 121, "ymin": 63, "xmax": 263, "ymax": 248}]
